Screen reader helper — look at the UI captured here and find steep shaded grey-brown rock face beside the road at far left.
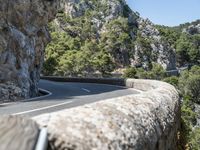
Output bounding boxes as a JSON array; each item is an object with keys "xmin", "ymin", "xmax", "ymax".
[{"xmin": 0, "ymin": 0, "xmax": 58, "ymax": 101}]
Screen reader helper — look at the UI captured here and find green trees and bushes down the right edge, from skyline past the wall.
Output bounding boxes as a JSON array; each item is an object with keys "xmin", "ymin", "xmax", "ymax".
[{"xmin": 153, "ymin": 20, "xmax": 200, "ymax": 150}]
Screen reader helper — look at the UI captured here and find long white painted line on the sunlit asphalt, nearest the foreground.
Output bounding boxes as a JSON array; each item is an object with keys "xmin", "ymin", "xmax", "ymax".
[{"xmin": 12, "ymin": 101, "xmax": 72, "ymax": 116}]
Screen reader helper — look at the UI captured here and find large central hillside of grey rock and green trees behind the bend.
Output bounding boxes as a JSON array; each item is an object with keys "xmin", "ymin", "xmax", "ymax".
[{"xmin": 44, "ymin": 0, "xmax": 176, "ymax": 76}]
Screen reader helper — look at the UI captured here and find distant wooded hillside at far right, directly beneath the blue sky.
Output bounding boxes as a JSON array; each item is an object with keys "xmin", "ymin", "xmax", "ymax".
[{"xmin": 156, "ymin": 20, "xmax": 200, "ymax": 67}]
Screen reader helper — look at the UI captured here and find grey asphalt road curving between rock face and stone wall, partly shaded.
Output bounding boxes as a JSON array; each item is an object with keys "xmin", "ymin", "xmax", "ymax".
[{"xmin": 0, "ymin": 80, "xmax": 139, "ymax": 117}]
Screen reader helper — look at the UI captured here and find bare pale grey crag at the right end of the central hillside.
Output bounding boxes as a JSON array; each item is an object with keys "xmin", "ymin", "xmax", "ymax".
[{"xmin": 133, "ymin": 18, "xmax": 176, "ymax": 70}]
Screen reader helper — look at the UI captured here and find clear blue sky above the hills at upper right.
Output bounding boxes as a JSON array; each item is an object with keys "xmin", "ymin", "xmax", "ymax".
[{"xmin": 127, "ymin": 0, "xmax": 200, "ymax": 26}]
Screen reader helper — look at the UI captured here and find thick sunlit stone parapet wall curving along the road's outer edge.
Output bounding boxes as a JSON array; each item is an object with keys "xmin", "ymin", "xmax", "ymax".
[{"xmin": 34, "ymin": 79, "xmax": 180, "ymax": 150}]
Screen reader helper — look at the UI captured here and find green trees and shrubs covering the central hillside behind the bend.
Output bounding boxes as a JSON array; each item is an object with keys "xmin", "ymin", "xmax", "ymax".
[{"xmin": 43, "ymin": 5, "xmax": 137, "ymax": 77}]
